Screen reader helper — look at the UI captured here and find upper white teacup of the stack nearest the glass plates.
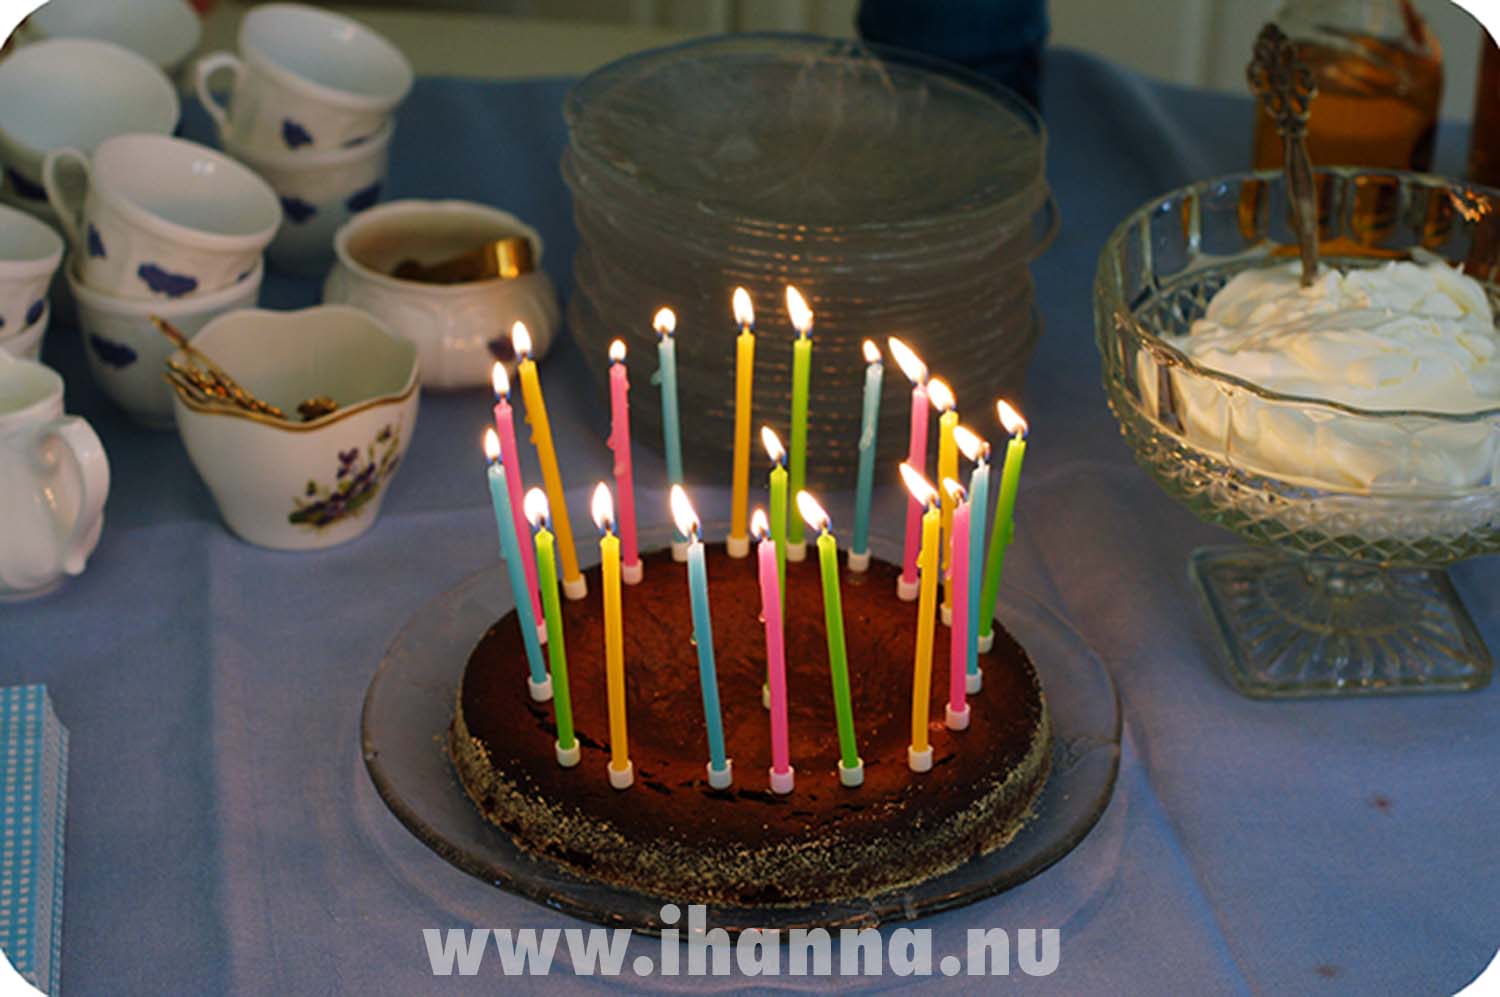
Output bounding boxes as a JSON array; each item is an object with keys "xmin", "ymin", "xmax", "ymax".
[{"xmin": 195, "ymin": 3, "xmax": 413, "ymax": 153}]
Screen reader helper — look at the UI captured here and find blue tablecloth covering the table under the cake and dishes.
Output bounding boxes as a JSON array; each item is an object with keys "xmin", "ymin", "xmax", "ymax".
[{"xmin": 0, "ymin": 44, "xmax": 1500, "ymax": 994}]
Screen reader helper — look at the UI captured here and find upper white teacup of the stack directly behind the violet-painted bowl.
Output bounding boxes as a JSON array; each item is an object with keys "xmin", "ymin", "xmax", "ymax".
[{"xmin": 42, "ymin": 135, "xmax": 281, "ymax": 300}]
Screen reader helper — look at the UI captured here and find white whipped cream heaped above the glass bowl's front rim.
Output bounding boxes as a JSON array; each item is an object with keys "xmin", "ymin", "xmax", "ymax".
[{"xmin": 1166, "ymin": 261, "xmax": 1500, "ymax": 412}]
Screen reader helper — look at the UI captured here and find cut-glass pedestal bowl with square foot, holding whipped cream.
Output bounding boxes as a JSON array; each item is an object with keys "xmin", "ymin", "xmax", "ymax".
[{"xmin": 1094, "ymin": 168, "xmax": 1500, "ymax": 697}]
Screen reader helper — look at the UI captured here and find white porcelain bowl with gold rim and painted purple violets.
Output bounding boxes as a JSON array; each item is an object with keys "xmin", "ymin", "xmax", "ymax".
[{"xmin": 173, "ymin": 304, "xmax": 422, "ymax": 550}]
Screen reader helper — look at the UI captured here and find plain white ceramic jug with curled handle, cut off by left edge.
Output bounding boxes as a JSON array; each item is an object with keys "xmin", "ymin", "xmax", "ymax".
[{"xmin": 0, "ymin": 352, "xmax": 110, "ymax": 600}]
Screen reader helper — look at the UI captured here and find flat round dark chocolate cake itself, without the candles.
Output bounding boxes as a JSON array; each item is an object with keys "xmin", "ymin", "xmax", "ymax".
[{"xmin": 449, "ymin": 547, "xmax": 1052, "ymax": 906}]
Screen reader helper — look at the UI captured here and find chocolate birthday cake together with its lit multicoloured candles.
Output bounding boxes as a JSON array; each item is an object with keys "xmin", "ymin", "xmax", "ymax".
[{"xmin": 447, "ymin": 291, "xmax": 1052, "ymax": 906}]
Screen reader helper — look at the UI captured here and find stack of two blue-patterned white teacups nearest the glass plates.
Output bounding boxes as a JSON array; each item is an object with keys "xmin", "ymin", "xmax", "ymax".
[{"xmin": 195, "ymin": 3, "xmax": 413, "ymax": 273}]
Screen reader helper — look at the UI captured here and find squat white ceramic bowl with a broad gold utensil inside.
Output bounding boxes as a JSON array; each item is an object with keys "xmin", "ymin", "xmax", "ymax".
[{"xmin": 323, "ymin": 201, "xmax": 558, "ymax": 388}]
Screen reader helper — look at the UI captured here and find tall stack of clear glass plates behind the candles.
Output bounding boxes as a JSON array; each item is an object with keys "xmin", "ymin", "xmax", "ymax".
[{"xmin": 563, "ymin": 34, "xmax": 1056, "ymax": 487}]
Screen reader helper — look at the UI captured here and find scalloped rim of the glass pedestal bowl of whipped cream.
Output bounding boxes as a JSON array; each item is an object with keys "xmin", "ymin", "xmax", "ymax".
[{"xmin": 1094, "ymin": 166, "xmax": 1500, "ymax": 426}]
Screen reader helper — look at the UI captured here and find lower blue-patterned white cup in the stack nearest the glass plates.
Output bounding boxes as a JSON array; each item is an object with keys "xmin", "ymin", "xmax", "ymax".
[{"xmin": 219, "ymin": 123, "xmax": 395, "ymax": 274}]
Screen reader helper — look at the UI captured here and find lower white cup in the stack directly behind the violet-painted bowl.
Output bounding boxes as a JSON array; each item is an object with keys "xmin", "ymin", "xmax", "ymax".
[{"xmin": 68, "ymin": 262, "xmax": 266, "ymax": 429}]
